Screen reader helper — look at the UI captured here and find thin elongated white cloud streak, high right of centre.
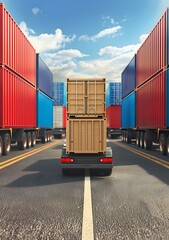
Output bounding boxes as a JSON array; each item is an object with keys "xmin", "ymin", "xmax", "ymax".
[{"xmin": 79, "ymin": 26, "xmax": 121, "ymax": 41}]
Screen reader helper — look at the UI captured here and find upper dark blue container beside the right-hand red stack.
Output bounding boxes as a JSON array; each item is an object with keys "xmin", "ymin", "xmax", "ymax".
[{"xmin": 122, "ymin": 55, "xmax": 136, "ymax": 98}]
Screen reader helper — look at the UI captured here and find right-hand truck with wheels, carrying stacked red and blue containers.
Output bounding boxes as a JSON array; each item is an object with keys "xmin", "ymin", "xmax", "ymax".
[{"xmin": 122, "ymin": 9, "xmax": 169, "ymax": 155}]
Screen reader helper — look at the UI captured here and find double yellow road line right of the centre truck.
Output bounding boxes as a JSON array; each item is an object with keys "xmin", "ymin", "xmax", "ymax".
[{"xmin": 114, "ymin": 142, "xmax": 169, "ymax": 169}]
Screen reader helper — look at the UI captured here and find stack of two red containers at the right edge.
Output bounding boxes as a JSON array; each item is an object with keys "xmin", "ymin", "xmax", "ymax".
[{"xmin": 136, "ymin": 10, "xmax": 169, "ymax": 128}]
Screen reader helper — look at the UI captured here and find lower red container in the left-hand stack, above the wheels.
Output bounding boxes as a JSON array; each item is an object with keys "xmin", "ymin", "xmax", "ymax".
[{"xmin": 0, "ymin": 67, "xmax": 36, "ymax": 128}]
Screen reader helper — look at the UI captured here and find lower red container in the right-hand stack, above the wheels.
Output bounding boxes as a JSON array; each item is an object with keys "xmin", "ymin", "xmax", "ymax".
[{"xmin": 136, "ymin": 72, "xmax": 166, "ymax": 128}]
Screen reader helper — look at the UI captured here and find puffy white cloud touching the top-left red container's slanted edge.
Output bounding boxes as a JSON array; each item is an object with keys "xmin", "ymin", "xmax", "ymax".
[{"xmin": 19, "ymin": 22, "xmax": 75, "ymax": 52}]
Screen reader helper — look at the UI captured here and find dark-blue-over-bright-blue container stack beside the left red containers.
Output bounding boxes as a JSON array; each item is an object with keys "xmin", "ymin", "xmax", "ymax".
[{"xmin": 36, "ymin": 54, "xmax": 53, "ymax": 128}]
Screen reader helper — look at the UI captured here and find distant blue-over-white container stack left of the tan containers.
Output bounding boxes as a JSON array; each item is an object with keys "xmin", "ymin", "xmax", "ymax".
[{"xmin": 53, "ymin": 82, "xmax": 66, "ymax": 129}]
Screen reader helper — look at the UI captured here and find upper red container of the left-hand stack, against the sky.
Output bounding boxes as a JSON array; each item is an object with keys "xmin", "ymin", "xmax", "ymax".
[{"xmin": 0, "ymin": 3, "xmax": 36, "ymax": 86}]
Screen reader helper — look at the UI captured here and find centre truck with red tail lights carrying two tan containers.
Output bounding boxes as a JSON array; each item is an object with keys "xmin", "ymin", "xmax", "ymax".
[{"xmin": 60, "ymin": 78, "xmax": 113, "ymax": 176}]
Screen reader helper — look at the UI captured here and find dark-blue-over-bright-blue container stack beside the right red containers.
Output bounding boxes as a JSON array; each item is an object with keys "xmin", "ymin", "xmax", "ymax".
[{"xmin": 121, "ymin": 55, "xmax": 136, "ymax": 128}]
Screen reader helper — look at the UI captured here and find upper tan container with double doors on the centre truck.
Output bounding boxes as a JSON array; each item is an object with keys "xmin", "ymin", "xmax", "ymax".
[{"xmin": 67, "ymin": 78, "xmax": 105, "ymax": 117}]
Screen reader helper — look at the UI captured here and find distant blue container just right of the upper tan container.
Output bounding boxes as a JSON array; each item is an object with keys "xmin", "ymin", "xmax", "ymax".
[{"xmin": 106, "ymin": 82, "xmax": 122, "ymax": 107}]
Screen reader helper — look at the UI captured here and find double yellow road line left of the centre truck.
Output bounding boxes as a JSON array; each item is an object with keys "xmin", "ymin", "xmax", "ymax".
[{"xmin": 0, "ymin": 141, "xmax": 58, "ymax": 169}]
